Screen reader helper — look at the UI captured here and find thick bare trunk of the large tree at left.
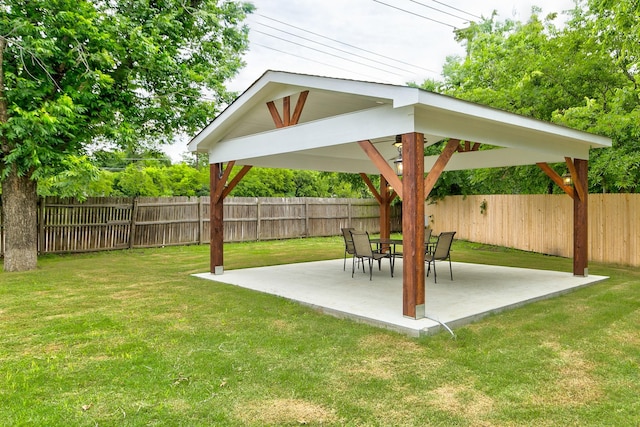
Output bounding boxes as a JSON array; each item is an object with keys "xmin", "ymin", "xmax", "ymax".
[{"xmin": 2, "ymin": 165, "xmax": 38, "ymax": 271}]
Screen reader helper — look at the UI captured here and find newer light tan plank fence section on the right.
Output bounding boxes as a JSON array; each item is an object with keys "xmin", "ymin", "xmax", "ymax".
[{"xmin": 425, "ymin": 194, "xmax": 640, "ymax": 266}]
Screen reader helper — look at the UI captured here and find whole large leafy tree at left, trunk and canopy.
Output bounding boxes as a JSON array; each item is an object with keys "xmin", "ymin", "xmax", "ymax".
[{"xmin": 0, "ymin": 0, "xmax": 253, "ymax": 271}]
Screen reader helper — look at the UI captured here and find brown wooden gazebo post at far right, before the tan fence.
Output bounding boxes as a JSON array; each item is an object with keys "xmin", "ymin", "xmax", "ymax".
[{"xmin": 572, "ymin": 159, "xmax": 589, "ymax": 277}]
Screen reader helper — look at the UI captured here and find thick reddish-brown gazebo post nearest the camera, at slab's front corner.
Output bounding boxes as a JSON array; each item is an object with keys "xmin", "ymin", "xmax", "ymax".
[{"xmin": 402, "ymin": 133, "xmax": 425, "ymax": 319}]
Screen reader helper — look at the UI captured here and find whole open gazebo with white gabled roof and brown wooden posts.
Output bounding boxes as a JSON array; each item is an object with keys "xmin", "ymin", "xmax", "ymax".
[{"xmin": 189, "ymin": 71, "xmax": 611, "ymax": 319}]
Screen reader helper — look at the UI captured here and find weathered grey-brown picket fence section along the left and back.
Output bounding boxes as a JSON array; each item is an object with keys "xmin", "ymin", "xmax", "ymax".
[{"xmin": 0, "ymin": 197, "xmax": 400, "ymax": 255}]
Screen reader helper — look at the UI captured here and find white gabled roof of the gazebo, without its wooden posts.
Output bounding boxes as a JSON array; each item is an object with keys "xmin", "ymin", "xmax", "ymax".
[{"xmin": 189, "ymin": 71, "xmax": 611, "ymax": 174}]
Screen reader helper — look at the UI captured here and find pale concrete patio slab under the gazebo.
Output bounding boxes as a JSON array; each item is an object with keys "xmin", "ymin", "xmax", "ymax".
[{"xmin": 195, "ymin": 259, "xmax": 607, "ymax": 337}]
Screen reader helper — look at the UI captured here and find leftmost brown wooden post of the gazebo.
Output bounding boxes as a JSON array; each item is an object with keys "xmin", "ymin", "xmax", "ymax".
[{"xmin": 209, "ymin": 163, "xmax": 226, "ymax": 274}]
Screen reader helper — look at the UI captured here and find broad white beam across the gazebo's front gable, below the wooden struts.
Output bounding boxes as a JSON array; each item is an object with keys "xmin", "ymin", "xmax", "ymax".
[{"xmin": 209, "ymin": 105, "xmax": 414, "ymax": 167}]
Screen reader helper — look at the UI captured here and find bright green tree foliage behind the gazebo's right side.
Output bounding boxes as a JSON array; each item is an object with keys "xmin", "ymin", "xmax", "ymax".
[{"xmin": 421, "ymin": 0, "xmax": 640, "ymax": 195}]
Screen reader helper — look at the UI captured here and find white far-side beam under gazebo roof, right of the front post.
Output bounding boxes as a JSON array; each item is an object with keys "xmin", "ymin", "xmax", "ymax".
[{"xmin": 424, "ymin": 148, "xmax": 589, "ymax": 171}]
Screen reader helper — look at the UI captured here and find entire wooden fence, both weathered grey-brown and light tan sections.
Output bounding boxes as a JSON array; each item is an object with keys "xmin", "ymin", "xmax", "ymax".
[{"xmin": 0, "ymin": 194, "xmax": 640, "ymax": 266}]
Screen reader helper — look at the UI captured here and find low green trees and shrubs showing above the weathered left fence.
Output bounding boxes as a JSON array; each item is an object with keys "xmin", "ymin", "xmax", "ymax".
[{"xmin": 38, "ymin": 150, "xmax": 372, "ymax": 200}]
